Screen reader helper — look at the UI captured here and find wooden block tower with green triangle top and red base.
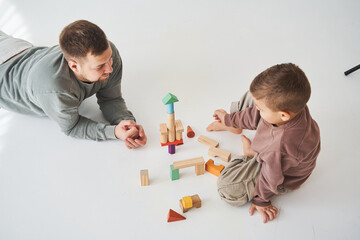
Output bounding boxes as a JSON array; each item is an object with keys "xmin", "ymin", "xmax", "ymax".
[{"xmin": 160, "ymin": 93, "xmax": 184, "ymax": 154}]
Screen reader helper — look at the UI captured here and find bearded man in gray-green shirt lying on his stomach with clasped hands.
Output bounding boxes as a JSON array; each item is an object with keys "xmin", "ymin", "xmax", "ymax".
[{"xmin": 0, "ymin": 20, "xmax": 147, "ymax": 149}]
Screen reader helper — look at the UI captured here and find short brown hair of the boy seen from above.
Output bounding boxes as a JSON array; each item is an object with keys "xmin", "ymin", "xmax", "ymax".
[{"xmin": 250, "ymin": 63, "xmax": 311, "ymax": 113}]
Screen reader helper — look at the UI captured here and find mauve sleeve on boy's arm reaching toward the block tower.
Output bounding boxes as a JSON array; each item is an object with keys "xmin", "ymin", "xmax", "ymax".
[{"xmin": 225, "ymin": 106, "xmax": 261, "ymax": 130}]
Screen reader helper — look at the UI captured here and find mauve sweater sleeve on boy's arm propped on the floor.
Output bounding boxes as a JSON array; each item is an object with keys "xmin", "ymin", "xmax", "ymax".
[{"xmin": 252, "ymin": 152, "xmax": 284, "ymax": 206}]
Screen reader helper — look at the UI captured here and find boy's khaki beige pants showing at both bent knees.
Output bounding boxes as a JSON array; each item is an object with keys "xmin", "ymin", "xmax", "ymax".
[{"xmin": 217, "ymin": 92, "xmax": 261, "ymax": 206}]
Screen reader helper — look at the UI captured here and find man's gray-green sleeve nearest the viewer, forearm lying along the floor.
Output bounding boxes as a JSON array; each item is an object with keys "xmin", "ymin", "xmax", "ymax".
[{"xmin": 36, "ymin": 93, "xmax": 116, "ymax": 141}]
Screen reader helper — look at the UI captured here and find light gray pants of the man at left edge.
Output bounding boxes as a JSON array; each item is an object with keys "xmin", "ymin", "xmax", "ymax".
[{"xmin": 0, "ymin": 31, "xmax": 33, "ymax": 65}]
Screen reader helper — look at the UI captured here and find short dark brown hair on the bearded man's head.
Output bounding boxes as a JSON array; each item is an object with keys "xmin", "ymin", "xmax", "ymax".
[{"xmin": 59, "ymin": 20, "xmax": 109, "ymax": 61}]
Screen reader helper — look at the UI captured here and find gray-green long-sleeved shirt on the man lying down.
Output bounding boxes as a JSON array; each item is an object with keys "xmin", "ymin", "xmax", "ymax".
[{"xmin": 0, "ymin": 42, "xmax": 135, "ymax": 141}]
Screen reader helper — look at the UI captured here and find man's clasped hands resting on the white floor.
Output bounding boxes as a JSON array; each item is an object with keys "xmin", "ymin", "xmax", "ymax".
[{"xmin": 115, "ymin": 120, "xmax": 147, "ymax": 149}]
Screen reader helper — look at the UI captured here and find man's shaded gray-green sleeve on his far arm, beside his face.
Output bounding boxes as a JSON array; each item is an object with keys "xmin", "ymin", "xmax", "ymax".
[{"xmin": 96, "ymin": 43, "xmax": 136, "ymax": 125}]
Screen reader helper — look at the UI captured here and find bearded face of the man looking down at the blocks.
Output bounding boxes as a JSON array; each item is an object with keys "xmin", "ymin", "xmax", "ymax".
[{"xmin": 75, "ymin": 46, "xmax": 113, "ymax": 82}]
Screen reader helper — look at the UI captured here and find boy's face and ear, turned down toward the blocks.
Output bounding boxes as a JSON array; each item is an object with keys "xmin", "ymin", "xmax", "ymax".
[{"xmin": 252, "ymin": 94, "xmax": 290, "ymax": 126}]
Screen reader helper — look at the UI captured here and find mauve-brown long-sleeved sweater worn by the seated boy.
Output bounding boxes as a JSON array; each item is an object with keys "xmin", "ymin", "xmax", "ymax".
[{"xmin": 225, "ymin": 106, "xmax": 320, "ymax": 206}]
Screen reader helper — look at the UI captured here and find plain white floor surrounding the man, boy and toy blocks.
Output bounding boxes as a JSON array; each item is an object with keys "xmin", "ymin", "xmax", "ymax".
[{"xmin": 0, "ymin": 0, "xmax": 360, "ymax": 240}]
